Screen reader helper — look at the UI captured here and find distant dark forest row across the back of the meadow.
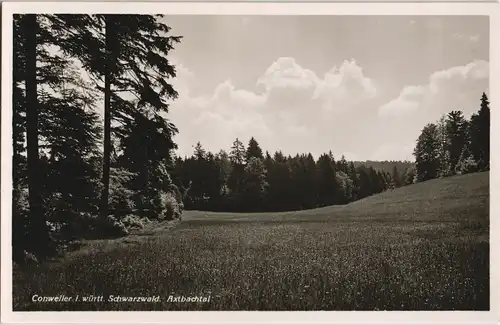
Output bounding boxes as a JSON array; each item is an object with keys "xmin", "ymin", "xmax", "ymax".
[{"xmin": 172, "ymin": 138, "xmax": 414, "ymax": 212}]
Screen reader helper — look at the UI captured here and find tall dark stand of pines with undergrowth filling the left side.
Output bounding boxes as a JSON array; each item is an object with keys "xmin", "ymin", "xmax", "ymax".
[{"xmin": 12, "ymin": 14, "xmax": 182, "ymax": 263}]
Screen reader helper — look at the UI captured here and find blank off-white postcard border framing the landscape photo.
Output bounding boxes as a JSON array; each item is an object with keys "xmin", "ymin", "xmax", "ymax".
[{"xmin": 1, "ymin": 2, "xmax": 500, "ymax": 324}]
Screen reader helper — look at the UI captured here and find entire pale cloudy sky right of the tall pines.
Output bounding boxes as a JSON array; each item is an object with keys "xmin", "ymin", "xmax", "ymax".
[{"xmin": 161, "ymin": 16, "xmax": 489, "ymax": 160}]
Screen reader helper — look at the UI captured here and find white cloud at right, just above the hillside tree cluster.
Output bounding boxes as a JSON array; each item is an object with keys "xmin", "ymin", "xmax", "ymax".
[{"xmin": 372, "ymin": 61, "xmax": 489, "ymax": 159}]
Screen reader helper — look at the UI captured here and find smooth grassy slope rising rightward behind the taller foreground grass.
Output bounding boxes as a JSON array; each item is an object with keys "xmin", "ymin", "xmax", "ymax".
[{"xmin": 183, "ymin": 172, "xmax": 489, "ymax": 227}]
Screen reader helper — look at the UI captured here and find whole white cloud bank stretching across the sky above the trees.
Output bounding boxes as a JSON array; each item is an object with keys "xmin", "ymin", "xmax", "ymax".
[{"xmin": 169, "ymin": 58, "xmax": 489, "ymax": 160}]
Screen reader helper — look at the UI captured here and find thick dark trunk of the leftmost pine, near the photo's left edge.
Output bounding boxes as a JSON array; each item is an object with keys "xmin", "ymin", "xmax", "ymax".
[{"xmin": 25, "ymin": 14, "xmax": 50, "ymax": 257}]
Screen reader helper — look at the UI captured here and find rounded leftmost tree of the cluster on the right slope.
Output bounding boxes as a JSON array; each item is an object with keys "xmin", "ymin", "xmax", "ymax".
[{"xmin": 413, "ymin": 123, "xmax": 440, "ymax": 182}]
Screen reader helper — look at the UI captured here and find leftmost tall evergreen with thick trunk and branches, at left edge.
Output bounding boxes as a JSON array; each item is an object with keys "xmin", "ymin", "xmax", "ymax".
[{"xmin": 13, "ymin": 15, "xmax": 110, "ymax": 259}]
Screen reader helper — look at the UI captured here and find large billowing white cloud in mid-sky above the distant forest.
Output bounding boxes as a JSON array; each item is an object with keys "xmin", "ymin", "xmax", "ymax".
[{"xmin": 169, "ymin": 57, "xmax": 376, "ymax": 156}]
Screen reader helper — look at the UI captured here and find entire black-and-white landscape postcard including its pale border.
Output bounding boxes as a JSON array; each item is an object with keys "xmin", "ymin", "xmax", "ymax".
[{"xmin": 2, "ymin": 3, "xmax": 498, "ymax": 317}]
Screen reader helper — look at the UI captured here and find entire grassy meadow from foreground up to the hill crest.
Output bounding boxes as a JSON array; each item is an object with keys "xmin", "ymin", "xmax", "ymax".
[{"xmin": 13, "ymin": 173, "xmax": 489, "ymax": 310}]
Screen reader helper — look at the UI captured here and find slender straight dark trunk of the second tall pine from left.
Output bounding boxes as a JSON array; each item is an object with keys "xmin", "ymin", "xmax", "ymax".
[{"xmin": 100, "ymin": 15, "xmax": 113, "ymax": 218}]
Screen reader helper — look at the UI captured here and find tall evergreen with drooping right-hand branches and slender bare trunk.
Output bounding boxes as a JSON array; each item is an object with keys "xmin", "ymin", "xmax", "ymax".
[{"xmin": 51, "ymin": 15, "xmax": 181, "ymax": 217}]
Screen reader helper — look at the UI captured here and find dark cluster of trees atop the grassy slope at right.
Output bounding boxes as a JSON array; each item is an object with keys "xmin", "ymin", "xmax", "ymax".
[{"xmin": 414, "ymin": 93, "xmax": 490, "ymax": 182}]
